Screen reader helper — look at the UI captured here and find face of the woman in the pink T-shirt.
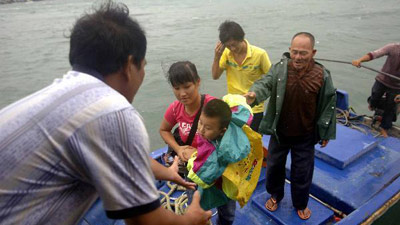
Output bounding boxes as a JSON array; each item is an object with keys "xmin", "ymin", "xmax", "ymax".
[{"xmin": 172, "ymin": 81, "xmax": 200, "ymax": 105}]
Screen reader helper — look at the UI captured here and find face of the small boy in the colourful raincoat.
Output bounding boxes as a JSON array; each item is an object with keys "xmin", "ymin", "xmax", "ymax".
[{"xmin": 197, "ymin": 113, "xmax": 226, "ymax": 141}]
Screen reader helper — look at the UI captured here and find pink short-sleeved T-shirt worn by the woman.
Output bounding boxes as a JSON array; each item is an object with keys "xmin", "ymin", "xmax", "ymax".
[{"xmin": 164, "ymin": 94, "xmax": 215, "ymax": 148}]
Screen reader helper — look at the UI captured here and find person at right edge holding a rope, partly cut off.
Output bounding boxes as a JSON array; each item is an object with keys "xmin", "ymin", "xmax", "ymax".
[{"xmin": 352, "ymin": 43, "xmax": 400, "ymax": 137}]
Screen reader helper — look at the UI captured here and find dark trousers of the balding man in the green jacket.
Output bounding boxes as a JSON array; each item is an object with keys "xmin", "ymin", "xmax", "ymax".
[{"xmin": 266, "ymin": 134, "xmax": 315, "ymax": 209}]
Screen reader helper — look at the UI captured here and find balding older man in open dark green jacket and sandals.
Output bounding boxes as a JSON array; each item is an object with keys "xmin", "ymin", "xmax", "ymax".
[{"xmin": 245, "ymin": 32, "xmax": 336, "ymax": 219}]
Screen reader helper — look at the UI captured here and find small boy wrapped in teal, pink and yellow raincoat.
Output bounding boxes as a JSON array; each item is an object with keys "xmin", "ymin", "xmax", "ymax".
[{"xmin": 188, "ymin": 95, "xmax": 262, "ymax": 224}]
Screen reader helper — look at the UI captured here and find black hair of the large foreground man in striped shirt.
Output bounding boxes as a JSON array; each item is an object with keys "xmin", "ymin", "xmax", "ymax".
[{"xmin": 69, "ymin": 1, "xmax": 147, "ymax": 76}]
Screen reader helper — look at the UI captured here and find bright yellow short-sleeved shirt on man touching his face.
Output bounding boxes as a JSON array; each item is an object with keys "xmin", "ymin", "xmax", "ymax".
[{"xmin": 219, "ymin": 40, "xmax": 271, "ymax": 113}]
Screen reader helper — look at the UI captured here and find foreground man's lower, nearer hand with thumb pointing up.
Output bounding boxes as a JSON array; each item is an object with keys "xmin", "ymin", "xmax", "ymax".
[{"xmin": 184, "ymin": 191, "xmax": 212, "ymax": 225}]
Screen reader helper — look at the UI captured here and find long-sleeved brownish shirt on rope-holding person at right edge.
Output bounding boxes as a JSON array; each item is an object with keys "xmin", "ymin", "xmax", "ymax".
[{"xmin": 368, "ymin": 43, "xmax": 400, "ymax": 90}]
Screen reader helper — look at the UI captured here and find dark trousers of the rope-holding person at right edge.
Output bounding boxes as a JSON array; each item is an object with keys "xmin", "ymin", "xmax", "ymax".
[{"xmin": 370, "ymin": 81, "xmax": 400, "ymax": 130}]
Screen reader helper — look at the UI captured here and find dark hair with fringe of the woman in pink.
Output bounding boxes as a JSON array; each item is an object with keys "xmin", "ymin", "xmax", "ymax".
[{"xmin": 167, "ymin": 61, "xmax": 200, "ymax": 87}]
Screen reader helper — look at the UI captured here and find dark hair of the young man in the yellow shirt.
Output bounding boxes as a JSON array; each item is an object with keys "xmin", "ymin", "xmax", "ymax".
[{"xmin": 218, "ymin": 20, "xmax": 244, "ymax": 44}]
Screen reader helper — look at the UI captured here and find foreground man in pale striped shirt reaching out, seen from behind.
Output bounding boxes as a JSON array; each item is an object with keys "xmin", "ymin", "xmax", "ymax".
[{"xmin": 0, "ymin": 2, "xmax": 211, "ymax": 225}]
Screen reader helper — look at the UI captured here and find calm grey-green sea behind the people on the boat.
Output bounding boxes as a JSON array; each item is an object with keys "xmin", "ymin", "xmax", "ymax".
[{"xmin": 0, "ymin": 0, "xmax": 400, "ymax": 149}]
